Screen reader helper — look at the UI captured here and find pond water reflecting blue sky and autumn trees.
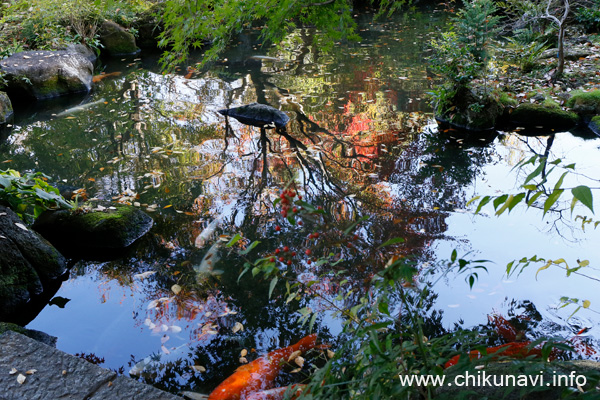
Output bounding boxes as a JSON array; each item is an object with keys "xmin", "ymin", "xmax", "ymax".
[{"xmin": 0, "ymin": 3, "xmax": 600, "ymax": 393}]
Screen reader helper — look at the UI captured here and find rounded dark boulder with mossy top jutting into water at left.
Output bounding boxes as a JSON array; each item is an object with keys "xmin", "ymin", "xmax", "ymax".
[{"xmin": 33, "ymin": 205, "xmax": 154, "ymax": 258}]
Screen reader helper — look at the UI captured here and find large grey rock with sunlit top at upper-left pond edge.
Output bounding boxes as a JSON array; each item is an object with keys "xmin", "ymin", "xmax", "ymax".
[{"xmin": 0, "ymin": 50, "xmax": 94, "ymax": 100}]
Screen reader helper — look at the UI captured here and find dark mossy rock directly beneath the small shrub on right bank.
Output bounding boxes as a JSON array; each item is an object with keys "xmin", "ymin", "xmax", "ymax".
[{"xmin": 436, "ymin": 87, "xmax": 504, "ymax": 132}]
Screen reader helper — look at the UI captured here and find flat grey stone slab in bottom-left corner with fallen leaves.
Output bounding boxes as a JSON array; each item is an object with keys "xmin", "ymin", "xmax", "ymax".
[{"xmin": 0, "ymin": 331, "xmax": 182, "ymax": 400}]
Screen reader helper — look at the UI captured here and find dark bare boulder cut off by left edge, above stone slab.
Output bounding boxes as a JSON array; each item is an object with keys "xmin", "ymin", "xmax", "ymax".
[{"xmin": 0, "ymin": 206, "xmax": 67, "ymax": 323}]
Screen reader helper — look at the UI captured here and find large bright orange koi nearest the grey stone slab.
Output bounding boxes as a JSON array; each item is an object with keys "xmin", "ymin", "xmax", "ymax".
[{"xmin": 208, "ymin": 333, "xmax": 317, "ymax": 400}]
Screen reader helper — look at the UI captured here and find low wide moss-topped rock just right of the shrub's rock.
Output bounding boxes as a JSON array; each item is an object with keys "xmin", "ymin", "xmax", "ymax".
[{"xmin": 510, "ymin": 103, "xmax": 579, "ymax": 132}]
